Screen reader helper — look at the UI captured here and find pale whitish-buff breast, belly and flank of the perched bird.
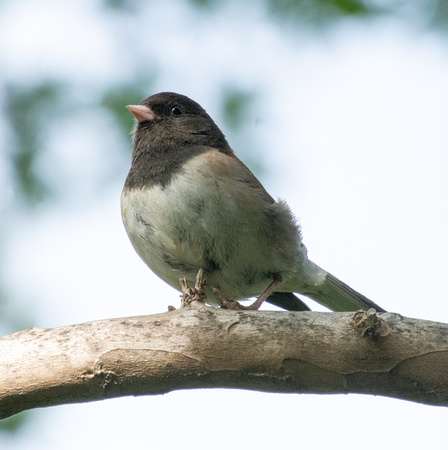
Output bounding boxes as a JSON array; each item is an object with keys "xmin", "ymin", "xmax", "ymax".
[{"xmin": 122, "ymin": 152, "xmax": 300, "ymax": 298}]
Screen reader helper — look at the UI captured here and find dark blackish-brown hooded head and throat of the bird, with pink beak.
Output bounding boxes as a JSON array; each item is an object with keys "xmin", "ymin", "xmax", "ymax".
[{"xmin": 126, "ymin": 92, "xmax": 233, "ymax": 187}]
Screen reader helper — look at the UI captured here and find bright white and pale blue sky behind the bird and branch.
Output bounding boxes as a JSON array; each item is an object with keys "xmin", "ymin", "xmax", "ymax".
[{"xmin": 0, "ymin": 0, "xmax": 448, "ymax": 450}]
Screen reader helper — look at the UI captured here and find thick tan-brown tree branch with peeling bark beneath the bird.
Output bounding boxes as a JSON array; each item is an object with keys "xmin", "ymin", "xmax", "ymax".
[{"xmin": 0, "ymin": 306, "xmax": 448, "ymax": 418}]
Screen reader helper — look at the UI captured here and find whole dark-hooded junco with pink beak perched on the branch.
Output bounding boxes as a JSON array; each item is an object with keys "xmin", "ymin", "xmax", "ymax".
[{"xmin": 121, "ymin": 92, "xmax": 384, "ymax": 311}]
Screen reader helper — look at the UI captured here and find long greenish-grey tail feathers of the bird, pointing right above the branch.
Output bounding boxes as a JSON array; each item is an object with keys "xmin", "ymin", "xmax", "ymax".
[{"xmin": 302, "ymin": 273, "xmax": 386, "ymax": 312}]
